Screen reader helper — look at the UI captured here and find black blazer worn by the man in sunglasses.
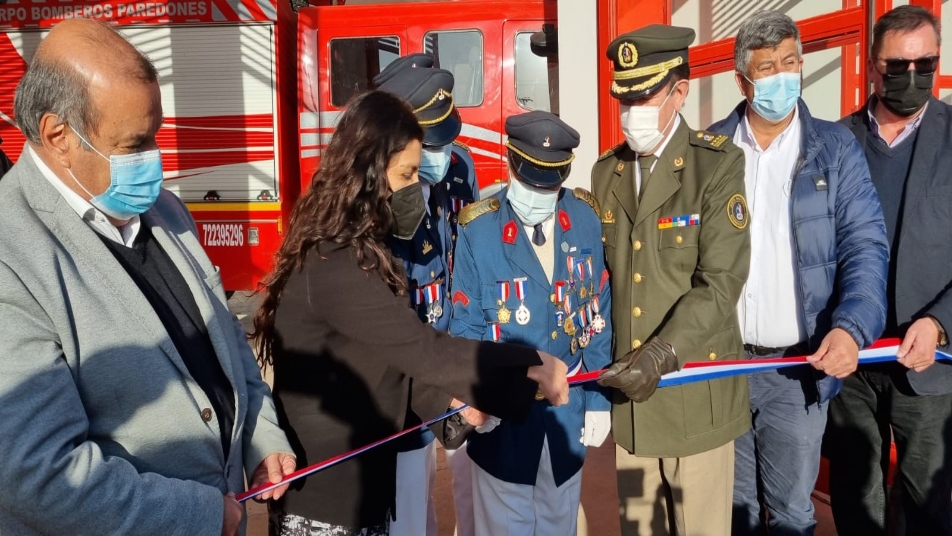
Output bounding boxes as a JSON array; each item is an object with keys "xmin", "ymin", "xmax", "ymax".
[{"xmin": 840, "ymin": 98, "xmax": 952, "ymax": 395}]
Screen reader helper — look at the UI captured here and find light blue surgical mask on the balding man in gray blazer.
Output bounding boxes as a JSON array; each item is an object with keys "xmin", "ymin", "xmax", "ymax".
[{"xmin": 66, "ymin": 126, "xmax": 162, "ymax": 220}]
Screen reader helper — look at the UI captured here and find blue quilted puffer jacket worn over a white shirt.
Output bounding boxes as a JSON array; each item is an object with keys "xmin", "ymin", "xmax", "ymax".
[{"xmin": 708, "ymin": 100, "xmax": 889, "ymax": 401}]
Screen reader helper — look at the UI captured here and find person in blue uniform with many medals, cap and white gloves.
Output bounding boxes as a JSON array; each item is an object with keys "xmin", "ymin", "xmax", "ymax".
[{"xmin": 450, "ymin": 111, "xmax": 612, "ymax": 535}]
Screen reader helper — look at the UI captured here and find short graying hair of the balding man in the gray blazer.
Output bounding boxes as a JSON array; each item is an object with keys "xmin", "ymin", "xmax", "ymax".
[{"xmin": 13, "ymin": 24, "xmax": 158, "ymax": 145}]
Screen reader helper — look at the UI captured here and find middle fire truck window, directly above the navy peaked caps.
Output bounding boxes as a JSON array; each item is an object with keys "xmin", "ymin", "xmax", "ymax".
[{"xmin": 423, "ymin": 30, "xmax": 483, "ymax": 106}]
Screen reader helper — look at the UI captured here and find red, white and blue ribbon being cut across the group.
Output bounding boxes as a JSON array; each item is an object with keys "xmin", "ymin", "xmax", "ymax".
[{"xmin": 236, "ymin": 340, "xmax": 952, "ymax": 502}]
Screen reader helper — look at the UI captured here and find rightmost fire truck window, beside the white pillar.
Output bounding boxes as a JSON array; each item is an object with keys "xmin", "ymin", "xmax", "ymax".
[{"xmin": 515, "ymin": 32, "xmax": 559, "ymax": 114}]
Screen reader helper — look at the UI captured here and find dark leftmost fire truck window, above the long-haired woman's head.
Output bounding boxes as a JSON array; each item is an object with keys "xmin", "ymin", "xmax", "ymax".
[{"xmin": 330, "ymin": 35, "xmax": 400, "ymax": 106}]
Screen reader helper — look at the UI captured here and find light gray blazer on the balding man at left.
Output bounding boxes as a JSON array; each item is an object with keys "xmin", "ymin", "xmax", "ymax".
[{"xmin": 0, "ymin": 151, "xmax": 291, "ymax": 536}]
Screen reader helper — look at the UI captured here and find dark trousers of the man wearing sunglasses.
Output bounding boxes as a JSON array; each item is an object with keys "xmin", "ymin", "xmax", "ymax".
[{"xmin": 824, "ymin": 363, "xmax": 952, "ymax": 536}]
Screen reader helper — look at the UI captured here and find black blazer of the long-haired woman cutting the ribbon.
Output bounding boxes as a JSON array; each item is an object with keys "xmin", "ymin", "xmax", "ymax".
[{"xmin": 272, "ymin": 244, "xmax": 541, "ymax": 528}]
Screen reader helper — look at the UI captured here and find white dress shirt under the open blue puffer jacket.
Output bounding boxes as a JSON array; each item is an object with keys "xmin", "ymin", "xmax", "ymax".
[{"xmin": 734, "ymin": 108, "xmax": 807, "ymax": 348}]
